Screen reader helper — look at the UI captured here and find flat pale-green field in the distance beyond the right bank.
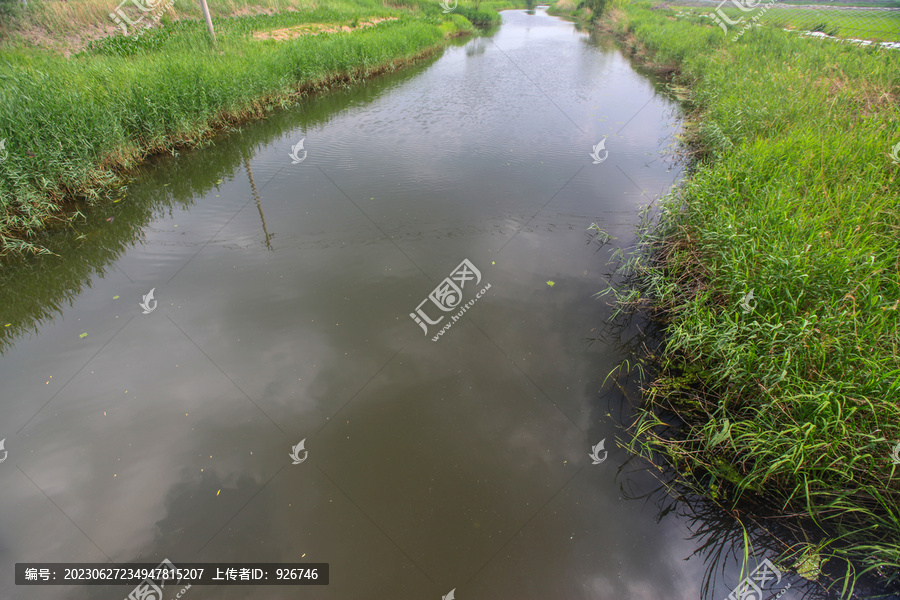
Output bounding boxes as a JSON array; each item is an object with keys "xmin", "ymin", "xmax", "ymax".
[{"xmin": 669, "ymin": 2, "xmax": 900, "ymax": 42}]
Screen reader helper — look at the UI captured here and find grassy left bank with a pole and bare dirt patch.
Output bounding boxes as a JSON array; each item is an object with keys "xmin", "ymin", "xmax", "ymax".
[{"xmin": 0, "ymin": 0, "xmax": 501, "ymax": 255}]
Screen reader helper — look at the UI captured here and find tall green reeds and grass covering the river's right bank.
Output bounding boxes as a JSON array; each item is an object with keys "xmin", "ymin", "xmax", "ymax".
[{"xmin": 592, "ymin": 4, "xmax": 900, "ymax": 595}]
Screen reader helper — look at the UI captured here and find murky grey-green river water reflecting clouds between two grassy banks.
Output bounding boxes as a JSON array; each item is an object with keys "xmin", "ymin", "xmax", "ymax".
[{"xmin": 0, "ymin": 8, "xmax": 824, "ymax": 600}]
